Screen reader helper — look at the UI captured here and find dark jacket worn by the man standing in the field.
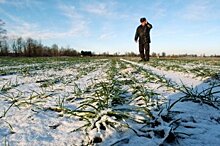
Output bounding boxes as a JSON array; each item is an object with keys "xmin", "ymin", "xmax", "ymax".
[{"xmin": 134, "ymin": 23, "xmax": 152, "ymax": 44}]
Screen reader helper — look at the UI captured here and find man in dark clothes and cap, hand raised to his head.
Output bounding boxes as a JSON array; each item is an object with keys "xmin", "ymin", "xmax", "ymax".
[{"xmin": 134, "ymin": 18, "xmax": 152, "ymax": 61}]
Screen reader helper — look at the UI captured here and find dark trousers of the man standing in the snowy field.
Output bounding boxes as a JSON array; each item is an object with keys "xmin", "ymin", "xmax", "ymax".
[{"xmin": 139, "ymin": 43, "xmax": 150, "ymax": 61}]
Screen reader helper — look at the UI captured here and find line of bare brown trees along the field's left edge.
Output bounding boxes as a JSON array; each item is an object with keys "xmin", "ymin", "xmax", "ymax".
[{"xmin": 0, "ymin": 19, "xmax": 80, "ymax": 57}]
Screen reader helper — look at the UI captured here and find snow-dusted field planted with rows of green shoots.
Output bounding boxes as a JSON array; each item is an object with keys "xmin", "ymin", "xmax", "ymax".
[{"xmin": 0, "ymin": 58, "xmax": 220, "ymax": 146}]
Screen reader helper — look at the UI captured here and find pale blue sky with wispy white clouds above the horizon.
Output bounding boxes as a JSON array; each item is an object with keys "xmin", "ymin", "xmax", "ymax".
[{"xmin": 0, "ymin": 0, "xmax": 220, "ymax": 55}]
